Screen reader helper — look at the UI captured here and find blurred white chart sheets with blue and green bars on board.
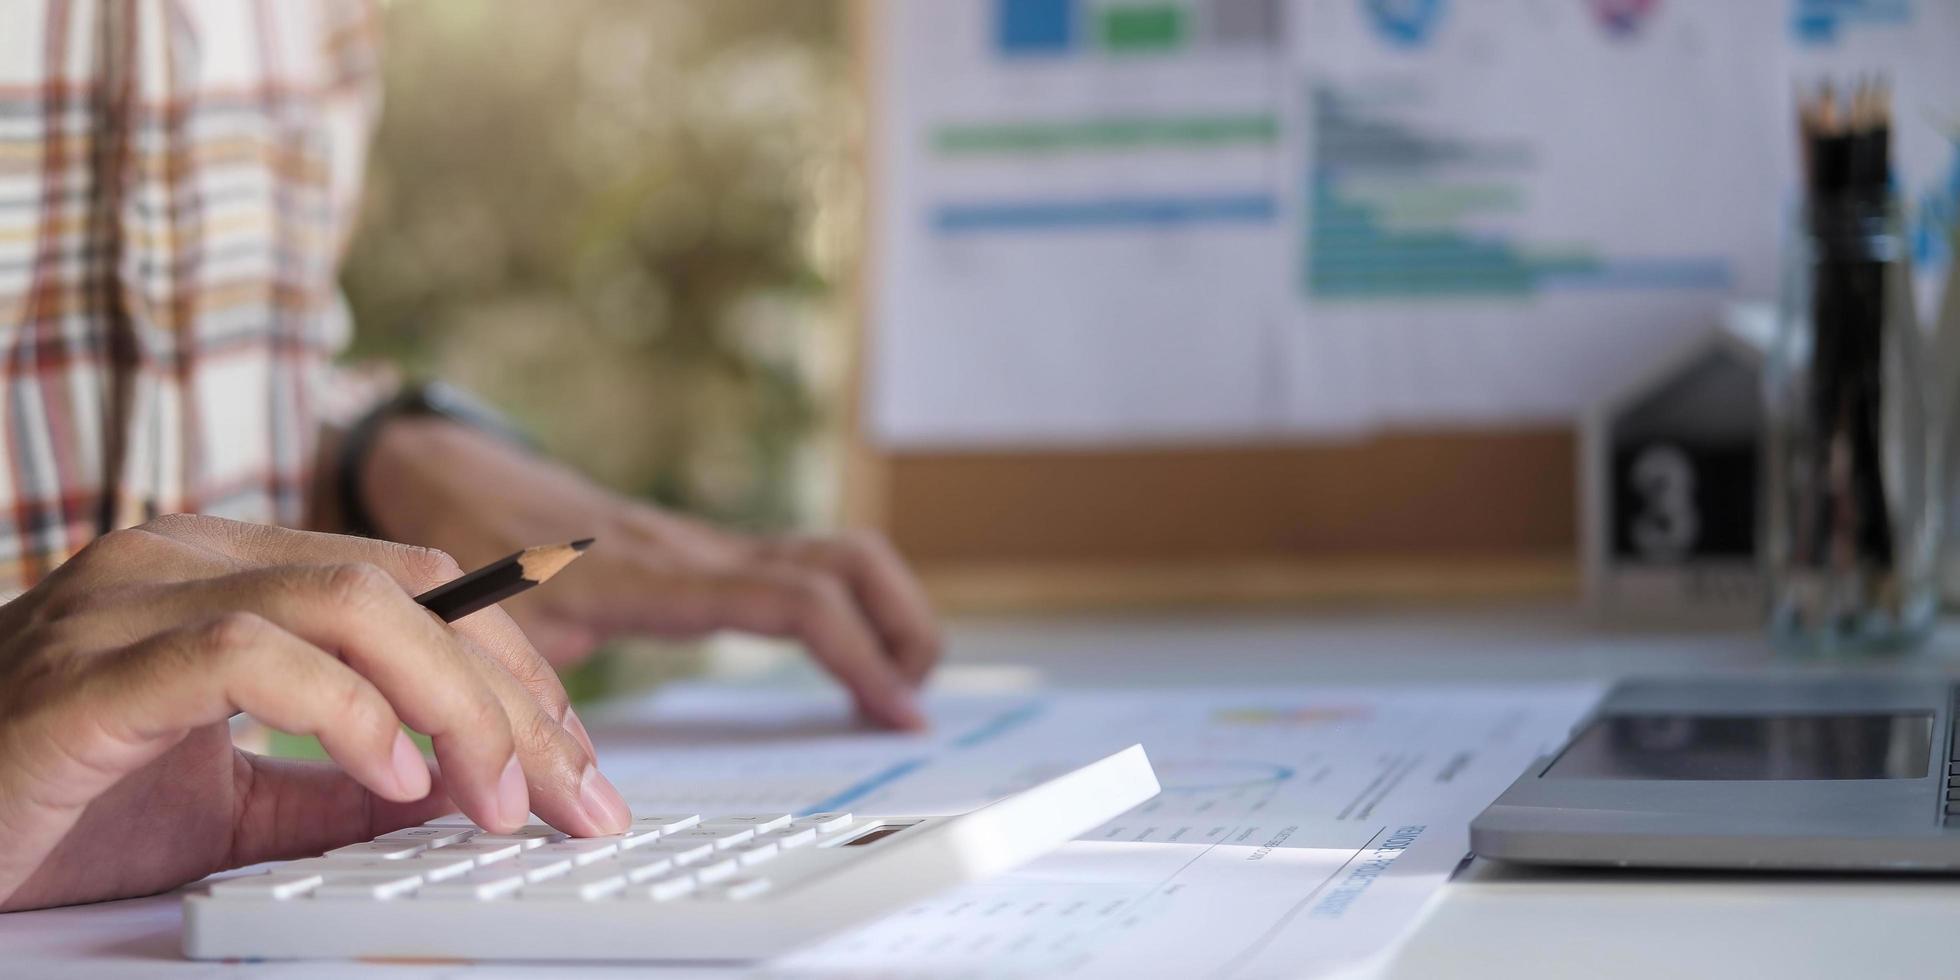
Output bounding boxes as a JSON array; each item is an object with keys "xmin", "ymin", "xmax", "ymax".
[{"xmin": 866, "ymin": 0, "xmax": 1960, "ymax": 449}]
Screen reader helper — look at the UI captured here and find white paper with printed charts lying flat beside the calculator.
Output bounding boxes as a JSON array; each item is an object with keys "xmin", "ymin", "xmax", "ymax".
[{"xmin": 608, "ymin": 686, "xmax": 1597, "ymax": 978}]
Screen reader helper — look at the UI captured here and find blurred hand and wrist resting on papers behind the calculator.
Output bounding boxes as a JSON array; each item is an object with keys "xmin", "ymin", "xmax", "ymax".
[{"xmin": 363, "ymin": 419, "xmax": 941, "ymax": 729}]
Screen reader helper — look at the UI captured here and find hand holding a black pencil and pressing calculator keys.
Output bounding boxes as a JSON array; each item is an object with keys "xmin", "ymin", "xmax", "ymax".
[{"xmin": 0, "ymin": 515, "xmax": 631, "ymax": 911}]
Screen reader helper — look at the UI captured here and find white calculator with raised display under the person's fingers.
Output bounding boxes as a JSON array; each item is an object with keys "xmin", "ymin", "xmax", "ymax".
[{"xmin": 184, "ymin": 745, "xmax": 1158, "ymax": 960}]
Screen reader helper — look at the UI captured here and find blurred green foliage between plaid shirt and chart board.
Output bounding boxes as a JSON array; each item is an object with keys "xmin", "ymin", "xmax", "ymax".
[{"xmin": 345, "ymin": 0, "xmax": 857, "ymax": 527}]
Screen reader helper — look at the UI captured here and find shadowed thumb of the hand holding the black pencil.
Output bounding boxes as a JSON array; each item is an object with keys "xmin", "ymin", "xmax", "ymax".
[{"xmin": 231, "ymin": 753, "xmax": 457, "ymax": 866}]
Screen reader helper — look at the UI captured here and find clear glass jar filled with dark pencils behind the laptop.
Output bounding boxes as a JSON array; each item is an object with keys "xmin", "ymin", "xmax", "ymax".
[{"xmin": 1760, "ymin": 194, "xmax": 1944, "ymax": 657}]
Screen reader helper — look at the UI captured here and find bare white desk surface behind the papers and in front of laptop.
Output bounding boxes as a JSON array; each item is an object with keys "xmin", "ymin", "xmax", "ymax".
[{"xmin": 897, "ymin": 610, "xmax": 1960, "ymax": 978}]
